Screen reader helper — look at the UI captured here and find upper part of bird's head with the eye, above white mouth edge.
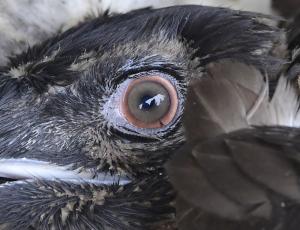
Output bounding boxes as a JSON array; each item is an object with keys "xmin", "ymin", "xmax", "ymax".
[{"xmin": 0, "ymin": 6, "xmax": 279, "ymax": 176}]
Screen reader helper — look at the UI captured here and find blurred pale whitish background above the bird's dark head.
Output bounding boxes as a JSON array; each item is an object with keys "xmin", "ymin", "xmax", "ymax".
[{"xmin": 0, "ymin": 0, "xmax": 300, "ymax": 65}]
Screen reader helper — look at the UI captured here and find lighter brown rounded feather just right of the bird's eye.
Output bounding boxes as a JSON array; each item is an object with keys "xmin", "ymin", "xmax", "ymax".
[{"xmin": 184, "ymin": 61, "xmax": 268, "ymax": 144}]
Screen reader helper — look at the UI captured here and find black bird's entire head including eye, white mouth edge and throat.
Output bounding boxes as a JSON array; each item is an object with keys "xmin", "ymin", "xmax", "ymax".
[{"xmin": 0, "ymin": 5, "xmax": 286, "ymax": 230}]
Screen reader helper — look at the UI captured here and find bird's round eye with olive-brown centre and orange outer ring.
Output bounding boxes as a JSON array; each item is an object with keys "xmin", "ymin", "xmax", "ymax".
[{"xmin": 121, "ymin": 76, "xmax": 178, "ymax": 128}]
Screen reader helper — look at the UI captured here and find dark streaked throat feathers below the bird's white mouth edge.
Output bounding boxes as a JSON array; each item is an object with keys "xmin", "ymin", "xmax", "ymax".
[{"xmin": 0, "ymin": 177, "xmax": 174, "ymax": 230}]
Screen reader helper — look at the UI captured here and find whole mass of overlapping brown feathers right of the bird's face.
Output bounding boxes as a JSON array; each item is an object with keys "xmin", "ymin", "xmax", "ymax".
[{"xmin": 167, "ymin": 61, "xmax": 300, "ymax": 230}]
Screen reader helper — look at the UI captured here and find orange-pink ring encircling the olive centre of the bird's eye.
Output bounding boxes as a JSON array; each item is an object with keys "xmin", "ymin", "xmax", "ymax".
[{"xmin": 120, "ymin": 75, "xmax": 178, "ymax": 129}]
